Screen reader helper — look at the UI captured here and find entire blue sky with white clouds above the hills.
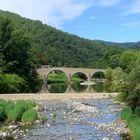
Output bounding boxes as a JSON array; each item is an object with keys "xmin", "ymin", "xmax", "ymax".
[{"xmin": 0, "ymin": 0, "xmax": 140, "ymax": 42}]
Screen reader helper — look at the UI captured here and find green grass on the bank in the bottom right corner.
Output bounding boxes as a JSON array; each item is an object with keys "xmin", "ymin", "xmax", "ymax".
[{"xmin": 121, "ymin": 106, "xmax": 140, "ymax": 140}]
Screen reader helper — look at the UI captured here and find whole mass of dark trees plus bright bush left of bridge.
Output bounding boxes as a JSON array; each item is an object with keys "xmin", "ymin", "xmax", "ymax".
[{"xmin": 0, "ymin": 15, "xmax": 40, "ymax": 93}]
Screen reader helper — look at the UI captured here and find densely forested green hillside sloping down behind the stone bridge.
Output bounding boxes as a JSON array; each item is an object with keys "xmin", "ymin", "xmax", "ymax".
[{"xmin": 0, "ymin": 11, "xmax": 123, "ymax": 68}]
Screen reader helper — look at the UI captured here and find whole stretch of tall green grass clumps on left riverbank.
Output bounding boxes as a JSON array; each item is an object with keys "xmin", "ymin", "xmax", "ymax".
[{"xmin": 0, "ymin": 100, "xmax": 38, "ymax": 124}]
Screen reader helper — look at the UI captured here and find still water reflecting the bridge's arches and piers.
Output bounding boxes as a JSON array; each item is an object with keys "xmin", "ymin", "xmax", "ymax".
[{"xmin": 42, "ymin": 82, "xmax": 105, "ymax": 93}]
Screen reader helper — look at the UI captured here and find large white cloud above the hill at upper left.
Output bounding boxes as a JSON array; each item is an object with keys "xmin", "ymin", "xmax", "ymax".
[{"xmin": 0, "ymin": 0, "xmax": 120, "ymax": 27}]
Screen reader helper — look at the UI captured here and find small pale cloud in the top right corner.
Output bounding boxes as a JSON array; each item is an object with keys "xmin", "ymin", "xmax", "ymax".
[{"xmin": 125, "ymin": 0, "xmax": 140, "ymax": 15}]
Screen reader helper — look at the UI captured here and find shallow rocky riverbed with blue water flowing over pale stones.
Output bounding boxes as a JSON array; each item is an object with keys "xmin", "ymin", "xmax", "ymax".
[{"xmin": 20, "ymin": 98, "xmax": 128, "ymax": 140}]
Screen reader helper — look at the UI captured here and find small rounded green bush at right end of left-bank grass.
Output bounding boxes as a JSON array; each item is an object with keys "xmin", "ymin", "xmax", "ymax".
[{"xmin": 22, "ymin": 110, "xmax": 38, "ymax": 124}]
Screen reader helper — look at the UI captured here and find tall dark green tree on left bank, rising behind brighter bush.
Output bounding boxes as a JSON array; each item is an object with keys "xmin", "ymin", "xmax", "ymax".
[{"xmin": 0, "ymin": 18, "xmax": 40, "ymax": 92}]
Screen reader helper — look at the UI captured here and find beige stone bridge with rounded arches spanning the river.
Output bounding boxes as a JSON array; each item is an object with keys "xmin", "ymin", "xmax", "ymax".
[{"xmin": 37, "ymin": 67, "xmax": 105, "ymax": 82}]
